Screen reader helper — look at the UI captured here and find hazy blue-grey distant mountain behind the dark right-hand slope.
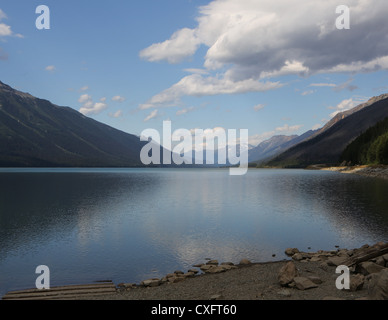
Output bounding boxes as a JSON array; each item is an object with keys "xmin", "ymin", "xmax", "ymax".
[{"xmin": 249, "ymin": 130, "xmax": 315, "ymax": 164}]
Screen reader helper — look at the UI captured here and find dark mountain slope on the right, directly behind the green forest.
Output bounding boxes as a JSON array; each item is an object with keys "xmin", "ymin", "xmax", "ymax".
[{"xmin": 267, "ymin": 94, "xmax": 388, "ymax": 167}]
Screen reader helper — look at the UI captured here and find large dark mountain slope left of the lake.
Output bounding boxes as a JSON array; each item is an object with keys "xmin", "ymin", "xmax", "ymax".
[{"xmin": 0, "ymin": 82, "xmax": 150, "ymax": 167}]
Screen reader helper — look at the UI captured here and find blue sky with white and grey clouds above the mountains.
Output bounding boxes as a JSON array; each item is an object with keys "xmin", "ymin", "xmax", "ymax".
[{"xmin": 0, "ymin": 0, "xmax": 388, "ymax": 145}]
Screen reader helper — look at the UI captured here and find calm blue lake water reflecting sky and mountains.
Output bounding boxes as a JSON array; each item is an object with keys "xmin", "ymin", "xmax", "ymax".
[{"xmin": 0, "ymin": 169, "xmax": 388, "ymax": 295}]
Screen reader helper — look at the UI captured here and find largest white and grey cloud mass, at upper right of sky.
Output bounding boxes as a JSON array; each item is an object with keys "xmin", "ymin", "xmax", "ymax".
[{"xmin": 140, "ymin": 0, "xmax": 388, "ymax": 107}]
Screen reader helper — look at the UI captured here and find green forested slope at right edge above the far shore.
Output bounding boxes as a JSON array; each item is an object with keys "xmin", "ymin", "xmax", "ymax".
[{"xmin": 341, "ymin": 117, "xmax": 388, "ymax": 165}]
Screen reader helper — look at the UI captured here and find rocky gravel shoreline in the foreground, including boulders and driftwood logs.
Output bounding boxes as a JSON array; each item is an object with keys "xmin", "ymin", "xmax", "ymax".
[{"xmin": 2, "ymin": 242, "xmax": 388, "ymax": 301}]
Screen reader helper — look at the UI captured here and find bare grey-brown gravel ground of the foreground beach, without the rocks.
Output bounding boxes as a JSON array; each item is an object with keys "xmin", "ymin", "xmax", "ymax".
[{"xmin": 80, "ymin": 261, "xmax": 368, "ymax": 300}]
